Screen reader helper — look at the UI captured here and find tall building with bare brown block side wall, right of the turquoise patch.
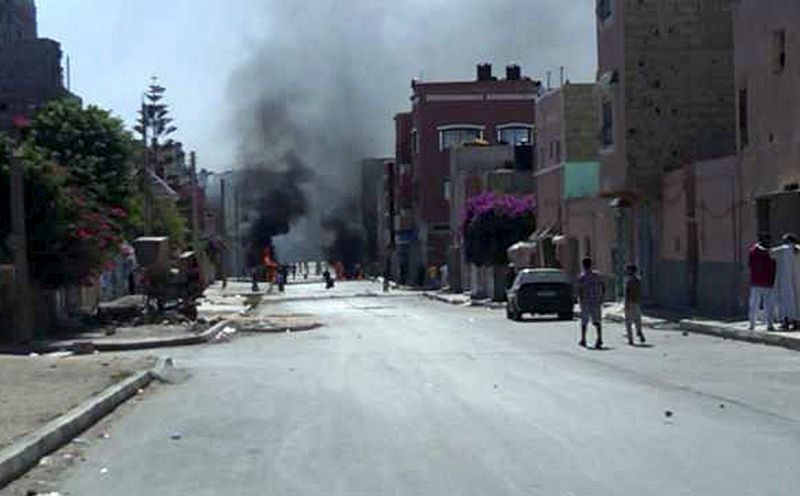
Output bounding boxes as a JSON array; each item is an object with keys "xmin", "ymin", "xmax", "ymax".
[{"xmin": 597, "ymin": 0, "xmax": 736, "ymax": 304}]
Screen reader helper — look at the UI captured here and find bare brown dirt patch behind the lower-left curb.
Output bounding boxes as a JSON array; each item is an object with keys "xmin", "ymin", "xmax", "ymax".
[{"xmin": 0, "ymin": 354, "xmax": 155, "ymax": 448}]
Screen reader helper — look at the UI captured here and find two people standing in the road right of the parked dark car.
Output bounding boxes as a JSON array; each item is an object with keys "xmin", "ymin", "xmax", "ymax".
[{"xmin": 578, "ymin": 257, "xmax": 647, "ymax": 350}]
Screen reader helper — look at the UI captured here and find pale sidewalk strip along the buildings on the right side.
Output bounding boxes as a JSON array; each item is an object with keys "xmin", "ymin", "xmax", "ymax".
[{"xmin": 423, "ymin": 292, "xmax": 800, "ymax": 351}]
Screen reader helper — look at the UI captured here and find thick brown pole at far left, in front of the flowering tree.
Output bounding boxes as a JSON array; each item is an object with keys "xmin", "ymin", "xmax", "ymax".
[{"xmin": 10, "ymin": 145, "xmax": 34, "ymax": 343}]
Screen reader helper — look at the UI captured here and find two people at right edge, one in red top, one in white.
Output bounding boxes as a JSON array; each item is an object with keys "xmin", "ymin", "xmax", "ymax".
[{"xmin": 748, "ymin": 234, "xmax": 800, "ymax": 331}]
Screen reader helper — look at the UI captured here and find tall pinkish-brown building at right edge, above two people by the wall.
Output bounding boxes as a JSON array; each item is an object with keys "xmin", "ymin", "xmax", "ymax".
[{"xmin": 734, "ymin": 0, "xmax": 800, "ymax": 242}]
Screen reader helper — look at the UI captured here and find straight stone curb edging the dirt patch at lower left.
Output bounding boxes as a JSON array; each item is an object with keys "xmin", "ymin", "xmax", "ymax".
[{"xmin": 0, "ymin": 365, "xmax": 158, "ymax": 488}]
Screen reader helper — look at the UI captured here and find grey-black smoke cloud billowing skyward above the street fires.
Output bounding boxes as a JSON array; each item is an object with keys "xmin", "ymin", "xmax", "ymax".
[{"xmin": 225, "ymin": 0, "xmax": 595, "ymax": 259}]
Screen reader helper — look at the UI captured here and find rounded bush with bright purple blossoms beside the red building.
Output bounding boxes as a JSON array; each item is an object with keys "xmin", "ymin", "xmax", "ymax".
[{"xmin": 461, "ymin": 192, "xmax": 536, "ymax": 266}]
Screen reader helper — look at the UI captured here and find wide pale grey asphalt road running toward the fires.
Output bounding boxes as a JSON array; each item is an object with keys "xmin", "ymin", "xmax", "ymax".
[{"xmin": 48, "ymin": 284, "xmax": 800, "ymax": 496}]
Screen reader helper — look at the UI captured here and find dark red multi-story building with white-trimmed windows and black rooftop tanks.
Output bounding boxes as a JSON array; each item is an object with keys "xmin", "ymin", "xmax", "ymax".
[{"xmin": 395, "ymin": 64, "xmax": 541, "ymax": 281}]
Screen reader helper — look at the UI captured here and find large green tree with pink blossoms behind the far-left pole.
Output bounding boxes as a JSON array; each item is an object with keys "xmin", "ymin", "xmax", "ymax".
[{"xmin": 0, "ymin": 100, "xmax": 140, "ymax": 287}]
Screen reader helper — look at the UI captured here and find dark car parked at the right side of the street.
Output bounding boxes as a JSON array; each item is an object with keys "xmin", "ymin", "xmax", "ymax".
[{"xmin": 506, "ymin": 269, "xmax": 575, "ymax": 320}]
